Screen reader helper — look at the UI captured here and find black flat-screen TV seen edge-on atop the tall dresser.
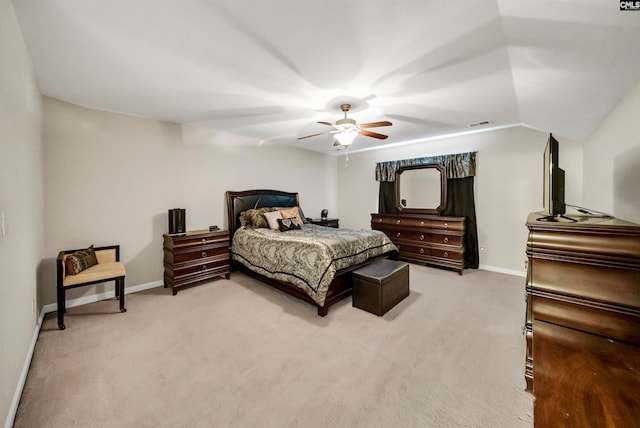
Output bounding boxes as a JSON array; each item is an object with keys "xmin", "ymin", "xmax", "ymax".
[{"xmin": 539, "ymin": 134, "xmax": 566, "ymax": 221}]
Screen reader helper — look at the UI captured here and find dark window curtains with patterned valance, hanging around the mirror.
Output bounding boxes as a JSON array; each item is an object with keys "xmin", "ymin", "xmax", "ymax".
[{"xmin": 376, "ymin": 152, "xmax": 480, "ymax": 269}]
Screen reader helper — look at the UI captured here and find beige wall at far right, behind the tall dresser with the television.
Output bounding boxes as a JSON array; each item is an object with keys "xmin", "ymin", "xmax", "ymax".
[{"xmin": 583, "ymin": 77, "xmax": 640, "ymax": 223}]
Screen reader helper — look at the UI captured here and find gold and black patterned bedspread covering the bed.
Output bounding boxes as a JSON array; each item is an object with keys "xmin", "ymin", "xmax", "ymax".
[{"xmin": 231, "ymin": 224, "xmax": 397, "ymax": 306}]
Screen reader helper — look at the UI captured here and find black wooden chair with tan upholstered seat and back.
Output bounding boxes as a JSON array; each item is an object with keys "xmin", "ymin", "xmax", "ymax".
[{"xmin": 56, "ymin": 245, "xmax": 127, "ymax": 330}]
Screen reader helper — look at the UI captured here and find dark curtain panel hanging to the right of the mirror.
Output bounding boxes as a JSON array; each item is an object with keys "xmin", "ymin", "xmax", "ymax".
[{"xmin": 442, "ymin": 177, "xmax": 480, "ymax": 269}]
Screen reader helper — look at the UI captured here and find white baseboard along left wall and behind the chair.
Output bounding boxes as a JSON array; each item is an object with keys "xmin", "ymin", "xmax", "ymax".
[{"xmin": 4, "ymin": 280, "xmax": 164, "ymax": 428}]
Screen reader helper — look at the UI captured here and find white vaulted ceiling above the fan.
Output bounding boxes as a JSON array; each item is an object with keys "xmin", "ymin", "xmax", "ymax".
[{"xmin": 13, "ymin": 0, "xmax": 640, "ymax": 153}]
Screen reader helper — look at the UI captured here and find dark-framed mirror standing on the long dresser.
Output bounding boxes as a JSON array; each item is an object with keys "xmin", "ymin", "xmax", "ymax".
[{"xmin": 396, "ymin": 163, "xmax": 447, "ymax": 215}]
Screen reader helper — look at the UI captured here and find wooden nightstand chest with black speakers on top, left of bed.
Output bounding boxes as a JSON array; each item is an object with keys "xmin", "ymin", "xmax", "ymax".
[{"xmin": 163, "ymin": 230, "xmax": 231, "ymax": 296}]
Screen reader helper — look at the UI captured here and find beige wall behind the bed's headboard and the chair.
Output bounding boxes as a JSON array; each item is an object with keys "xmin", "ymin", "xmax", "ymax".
[{"xmin": 43, "ymin": 97, "xmax": 336, "ymax": 304}]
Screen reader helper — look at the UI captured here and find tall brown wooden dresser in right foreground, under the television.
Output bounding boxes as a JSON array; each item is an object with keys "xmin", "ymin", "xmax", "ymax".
[{"xmin": 525, "ymin": 213, "xmax": 640, "ymax": 428}]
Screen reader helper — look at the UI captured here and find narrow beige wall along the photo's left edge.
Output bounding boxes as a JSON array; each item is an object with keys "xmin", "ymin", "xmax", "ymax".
[{"xmin": 0, "ymin": 0, "xmax": 43, "ymax": 424}]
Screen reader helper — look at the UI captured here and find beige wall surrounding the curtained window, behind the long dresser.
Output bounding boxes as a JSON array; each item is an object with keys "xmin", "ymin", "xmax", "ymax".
[{"xmin": 338, "ymin": 127, "xmax": 582, "ymax": 274}]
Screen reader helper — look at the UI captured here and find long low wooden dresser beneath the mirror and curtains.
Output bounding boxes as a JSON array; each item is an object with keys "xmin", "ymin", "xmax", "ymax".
[{"xmin": 371, "ymin": 214, "xmax": 465, "ymax": 275}]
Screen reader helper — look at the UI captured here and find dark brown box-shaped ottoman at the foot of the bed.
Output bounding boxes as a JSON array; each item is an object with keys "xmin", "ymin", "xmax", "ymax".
[{"xmin": 353, "ymin": 259, "xmax": 409, "ymax": 316}]
